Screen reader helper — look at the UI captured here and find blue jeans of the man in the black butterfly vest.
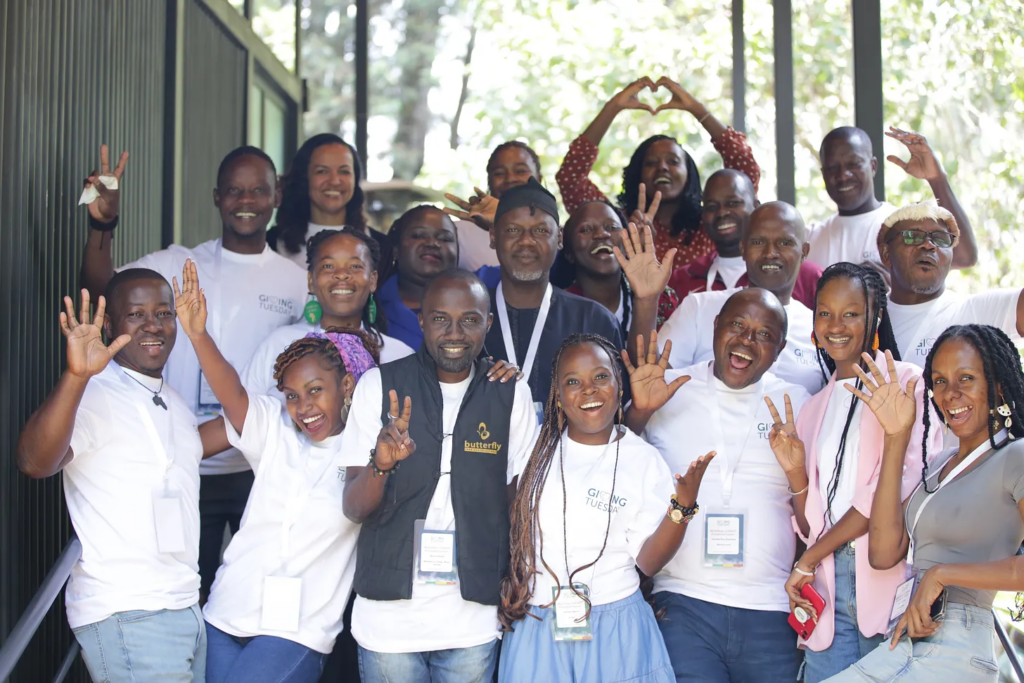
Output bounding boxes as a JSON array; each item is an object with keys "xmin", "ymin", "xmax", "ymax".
[{"xmin": 359, "ymin": 640, "xmax": 501, "ymax": 683}]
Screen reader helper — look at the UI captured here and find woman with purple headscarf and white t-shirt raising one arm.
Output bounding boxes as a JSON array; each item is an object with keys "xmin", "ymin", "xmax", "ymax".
[{"xmin": 174, "ymin": 260, "xmax": 378, "ymax": 683}]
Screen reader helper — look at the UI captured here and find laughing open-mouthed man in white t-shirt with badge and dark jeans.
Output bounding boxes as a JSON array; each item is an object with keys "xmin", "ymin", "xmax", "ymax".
[{"xmin": 627, "ymin": 288, "xmax": 810, "ymax": 683}]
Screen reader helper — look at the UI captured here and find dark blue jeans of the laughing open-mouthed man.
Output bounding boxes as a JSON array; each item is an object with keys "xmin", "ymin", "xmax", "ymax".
[{"xmin": 654, "ymin": 591, "xmax": 801, "ymax": 683}]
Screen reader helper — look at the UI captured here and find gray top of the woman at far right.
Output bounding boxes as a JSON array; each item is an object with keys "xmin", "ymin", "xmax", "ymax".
[{"xmin": 906, "ymin": 439, "xmax": 1024, "ymax": 609}]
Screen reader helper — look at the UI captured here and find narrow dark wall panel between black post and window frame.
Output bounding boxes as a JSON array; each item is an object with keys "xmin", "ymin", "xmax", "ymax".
[{"xmin": 181, "ymin": 0, "xmax": 248, "ymax": 245}]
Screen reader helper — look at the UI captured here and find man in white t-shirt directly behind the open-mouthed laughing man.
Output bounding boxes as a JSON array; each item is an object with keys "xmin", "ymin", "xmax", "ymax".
[{"xmin": 655, "ymin": 202, "xmax": 824, "ymax": 393}]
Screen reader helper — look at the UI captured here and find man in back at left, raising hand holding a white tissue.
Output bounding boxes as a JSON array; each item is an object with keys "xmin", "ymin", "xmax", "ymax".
[{"xmin": 82, "ymin": 145, "xmax": 307, "ymax": 596}]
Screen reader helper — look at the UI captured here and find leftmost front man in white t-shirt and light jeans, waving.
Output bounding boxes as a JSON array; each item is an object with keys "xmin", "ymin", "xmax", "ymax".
[{"xmin": 17, "ymin": 268, "xmax": 206, "ymax": 683}]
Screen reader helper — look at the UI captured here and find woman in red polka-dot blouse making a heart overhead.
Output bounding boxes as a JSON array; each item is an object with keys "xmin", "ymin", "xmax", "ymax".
[{"xmin": 555, "ymin": 77, "xmax": 761, "ymax": 267}]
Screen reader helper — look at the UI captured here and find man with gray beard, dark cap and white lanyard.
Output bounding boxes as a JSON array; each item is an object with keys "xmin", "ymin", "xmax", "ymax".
[{"xmin": 485, "ymin": 178, "xmax": 623, "ymax": 416}]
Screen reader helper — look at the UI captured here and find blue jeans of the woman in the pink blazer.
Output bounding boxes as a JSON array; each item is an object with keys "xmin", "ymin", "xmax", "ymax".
[{"xmin": 804, "ymin": 544, "xmax": 886, "ymax": 683}]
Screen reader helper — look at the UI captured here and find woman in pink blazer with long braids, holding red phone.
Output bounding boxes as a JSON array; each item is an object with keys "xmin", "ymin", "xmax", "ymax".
[{"xmin": 768, "ymin": 262, "xmax": 941, "ymax": 683}]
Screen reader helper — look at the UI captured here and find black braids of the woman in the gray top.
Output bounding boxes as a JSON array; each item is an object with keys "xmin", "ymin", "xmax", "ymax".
[{"xmin": 921, "ymin": 325, "xmax": 1024, "ymax": 494}]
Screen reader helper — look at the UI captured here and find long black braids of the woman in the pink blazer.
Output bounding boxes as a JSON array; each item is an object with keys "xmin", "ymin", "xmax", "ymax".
[{"xmin": 814, "ymin": 261, "xmax": 900, "ymax": 538}]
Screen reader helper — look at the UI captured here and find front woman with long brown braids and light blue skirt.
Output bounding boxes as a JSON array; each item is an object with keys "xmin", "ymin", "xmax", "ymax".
[{"xmin": 499, "ymin": 333, "xmax": 714, "ymax": 683}]
